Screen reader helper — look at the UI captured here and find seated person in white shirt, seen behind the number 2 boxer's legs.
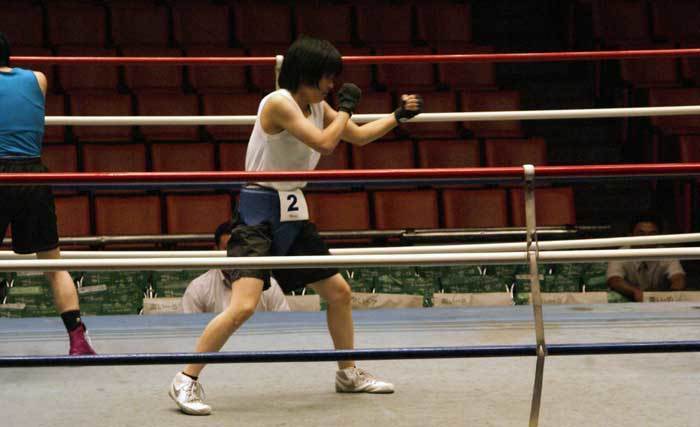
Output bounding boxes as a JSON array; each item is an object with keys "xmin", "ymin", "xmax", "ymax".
[{"xmin": 182, "ymin": 221, "xmax": 289, "ymax": 313}]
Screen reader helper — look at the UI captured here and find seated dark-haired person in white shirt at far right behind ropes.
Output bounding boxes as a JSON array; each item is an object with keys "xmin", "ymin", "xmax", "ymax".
[{"xmin": 607, "ymin": 214, "xmax": 685, "ymax": 302}]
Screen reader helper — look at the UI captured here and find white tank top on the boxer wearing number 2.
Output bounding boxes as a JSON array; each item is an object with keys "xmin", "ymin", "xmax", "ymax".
[{"xmin": 245, "ymin": 89, "xmax": 323, "ymax": 191}]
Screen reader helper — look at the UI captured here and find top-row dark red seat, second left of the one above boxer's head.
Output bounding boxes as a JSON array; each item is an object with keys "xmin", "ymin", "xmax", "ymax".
[{"xmin": 173, "ymin": 1, "xmax": 231, "ymax": 47}]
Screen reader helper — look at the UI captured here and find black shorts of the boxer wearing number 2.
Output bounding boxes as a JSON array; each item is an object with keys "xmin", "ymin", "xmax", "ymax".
[{"xmin": 224, "ymin": 221, "xmax": 338, "ymax": 293}]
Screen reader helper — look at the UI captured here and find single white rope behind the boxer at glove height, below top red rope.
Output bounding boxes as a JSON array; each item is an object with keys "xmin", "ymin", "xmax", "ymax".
[{"xmin": 46, "ymin": 105, "xmax": 700, "ymax": 126}]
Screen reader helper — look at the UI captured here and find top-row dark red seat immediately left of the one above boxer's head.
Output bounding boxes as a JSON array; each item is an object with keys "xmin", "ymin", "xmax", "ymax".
[{"xmin": 233, "ymin": 0, "xmax": 292, "ymax": 47}]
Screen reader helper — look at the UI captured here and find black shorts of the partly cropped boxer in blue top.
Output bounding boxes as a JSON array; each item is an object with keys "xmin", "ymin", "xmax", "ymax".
[{"xmin": 0, "ymin": 159, "xmax": 58, "ymax": 254}]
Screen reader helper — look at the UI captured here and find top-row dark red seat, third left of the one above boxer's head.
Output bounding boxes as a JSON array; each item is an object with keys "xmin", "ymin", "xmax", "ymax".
[{"xmin": 110, "ymin": 1, "xmax": 170, "ymax": 47}]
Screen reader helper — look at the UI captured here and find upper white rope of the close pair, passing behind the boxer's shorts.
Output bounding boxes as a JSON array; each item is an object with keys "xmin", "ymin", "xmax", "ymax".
[{"xmin": 0, "ymin": 233, "xmax": 700, "ymax": 260}]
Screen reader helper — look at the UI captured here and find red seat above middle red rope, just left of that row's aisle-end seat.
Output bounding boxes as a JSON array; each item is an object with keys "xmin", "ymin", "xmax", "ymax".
[{"xmin": 418, "ymin": 139, "xmax": 481, "ymax": 168}]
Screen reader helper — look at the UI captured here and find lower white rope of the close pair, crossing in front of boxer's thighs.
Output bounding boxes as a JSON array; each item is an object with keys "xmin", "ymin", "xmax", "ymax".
[{"xmin": 0, "ymin": 248, "xmax": 700, "ymax": 272}]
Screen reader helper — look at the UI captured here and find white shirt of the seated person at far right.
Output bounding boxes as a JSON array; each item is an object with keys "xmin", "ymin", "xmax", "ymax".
[{"xmin": 606, "ymin": 260, "xmax": 685, "ymax": 291}]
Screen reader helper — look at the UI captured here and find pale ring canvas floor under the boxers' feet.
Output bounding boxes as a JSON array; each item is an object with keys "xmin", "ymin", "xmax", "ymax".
[{"xmin": 0, "ymin": 303, "xmax": 700, "ymax": 427}]
